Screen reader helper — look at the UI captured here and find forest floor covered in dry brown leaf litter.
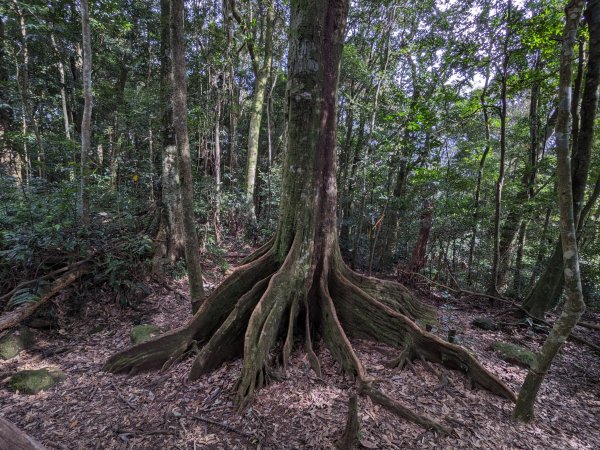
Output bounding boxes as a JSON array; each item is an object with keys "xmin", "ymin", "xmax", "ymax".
[{"xmin": 0, "ymin": 248, "xmax": 600, "ymax": 449}]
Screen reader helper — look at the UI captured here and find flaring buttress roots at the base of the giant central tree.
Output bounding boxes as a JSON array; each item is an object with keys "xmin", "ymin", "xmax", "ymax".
[{"xmin": 104, "ymin": 244, "xmax": 515, "ymax": 434}]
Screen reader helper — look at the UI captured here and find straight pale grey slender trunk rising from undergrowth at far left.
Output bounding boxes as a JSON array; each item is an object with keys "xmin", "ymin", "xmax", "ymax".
[{"xmin": 79, "ymin": 0, "xmax": 92, "ymax": 225}]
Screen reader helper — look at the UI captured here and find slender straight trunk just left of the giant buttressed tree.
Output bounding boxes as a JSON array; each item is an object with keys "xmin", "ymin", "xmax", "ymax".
[{"xmin": 171, "ymin": 0, "xmax": 204, "ymax": 312}]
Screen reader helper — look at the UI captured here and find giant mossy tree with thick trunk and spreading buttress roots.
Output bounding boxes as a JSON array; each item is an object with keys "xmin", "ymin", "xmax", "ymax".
[{"xmin": 104, "ymin": 0, "xmax": 514, "ymax": 431}]
